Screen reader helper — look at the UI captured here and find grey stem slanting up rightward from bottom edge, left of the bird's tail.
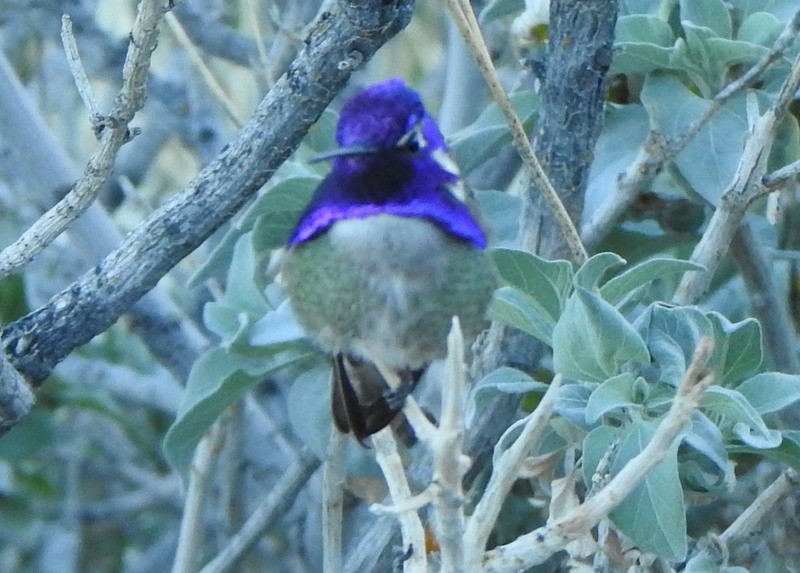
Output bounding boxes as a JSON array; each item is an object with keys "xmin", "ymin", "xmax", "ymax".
[{"xmin": 200, "ymin": 452, "xmax": 319, "ymax": 573}]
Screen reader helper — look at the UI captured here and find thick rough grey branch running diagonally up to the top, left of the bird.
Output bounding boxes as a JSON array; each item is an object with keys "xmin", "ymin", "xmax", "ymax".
[{"xmin": 0, "ymin": 0, "xmax": 414, "ymax": 386}]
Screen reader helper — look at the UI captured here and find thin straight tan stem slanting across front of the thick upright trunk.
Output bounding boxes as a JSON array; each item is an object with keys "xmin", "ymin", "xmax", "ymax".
[{"xmin": 447, "ymin": 0, "xmax": 588, "ymax": 265}]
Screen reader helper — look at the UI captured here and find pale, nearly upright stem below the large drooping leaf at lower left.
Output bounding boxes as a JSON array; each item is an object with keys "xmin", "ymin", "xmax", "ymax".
[{"xmin": 172, "ymin": 420, "xmax": 225, "ymax": 573}]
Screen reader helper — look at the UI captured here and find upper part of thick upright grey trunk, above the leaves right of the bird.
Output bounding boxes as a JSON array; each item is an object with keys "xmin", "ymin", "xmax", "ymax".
[{"xmin": 522, "ymin": 0, "xmax": 617, "ymax": 259}]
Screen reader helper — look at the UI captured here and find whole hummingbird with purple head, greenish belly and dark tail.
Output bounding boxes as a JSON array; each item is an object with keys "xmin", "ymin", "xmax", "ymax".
[{"xmin": 281, "ymin": 79, "xmax": 497, "ymax": 445}]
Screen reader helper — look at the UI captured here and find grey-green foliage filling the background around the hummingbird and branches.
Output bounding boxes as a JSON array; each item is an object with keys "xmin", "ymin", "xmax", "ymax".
[{"xmin": 0, "ymin": 0, "xmax": 800, "ymax": 573}]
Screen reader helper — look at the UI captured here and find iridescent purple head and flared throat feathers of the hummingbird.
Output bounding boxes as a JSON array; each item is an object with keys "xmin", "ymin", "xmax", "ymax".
[{"xmin": 288, "ymin": 79, "xmax": 487, "ymax": 249}]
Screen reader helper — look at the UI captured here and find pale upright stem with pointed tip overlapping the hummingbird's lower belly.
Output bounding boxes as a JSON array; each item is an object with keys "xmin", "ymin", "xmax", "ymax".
[{"xmin": 430, "ymin": 317, "xmax": 466, "ymax": 573}]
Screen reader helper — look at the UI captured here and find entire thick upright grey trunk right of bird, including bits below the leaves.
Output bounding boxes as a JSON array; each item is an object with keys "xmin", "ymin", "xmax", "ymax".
[{"xmin": 466, "ymin": 0, "xmax": 617, "ymax": 488}]
